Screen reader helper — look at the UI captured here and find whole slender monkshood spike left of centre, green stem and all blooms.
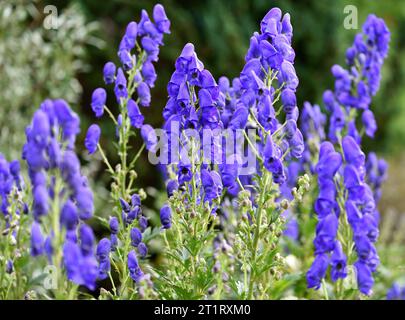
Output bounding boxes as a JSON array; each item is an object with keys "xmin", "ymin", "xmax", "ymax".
[{"xmin": 84, "ymin": 4, "xmax": 170, "ymax": 295}]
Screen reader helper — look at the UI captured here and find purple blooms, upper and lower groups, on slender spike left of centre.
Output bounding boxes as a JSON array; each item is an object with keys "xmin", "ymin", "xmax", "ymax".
[{"xmin": 85, "ymin": 4, "xmax": 170, "ymax": 281}]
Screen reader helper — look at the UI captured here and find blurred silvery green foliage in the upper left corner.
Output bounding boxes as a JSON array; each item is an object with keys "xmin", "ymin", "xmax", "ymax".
[{"xmin": 0, "ymin": 0, "xmax": 102, "ymax": 158}]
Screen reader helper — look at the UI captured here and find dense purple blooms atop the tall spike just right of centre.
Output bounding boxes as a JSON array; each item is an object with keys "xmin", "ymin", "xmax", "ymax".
[{"xmin": 240, "ymin": 8, "xmax": 304, "ymax": 185}]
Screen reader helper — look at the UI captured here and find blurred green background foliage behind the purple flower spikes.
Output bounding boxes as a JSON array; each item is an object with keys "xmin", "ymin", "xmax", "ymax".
[{"xmin": 0, "ymin": 0, "xmax": 405, "ymax": 213}]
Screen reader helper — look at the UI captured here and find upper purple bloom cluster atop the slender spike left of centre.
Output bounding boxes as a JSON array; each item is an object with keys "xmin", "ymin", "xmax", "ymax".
[{"xmin": 85, "ymin": 4, "xmax": 170, "ymax": 154}]
